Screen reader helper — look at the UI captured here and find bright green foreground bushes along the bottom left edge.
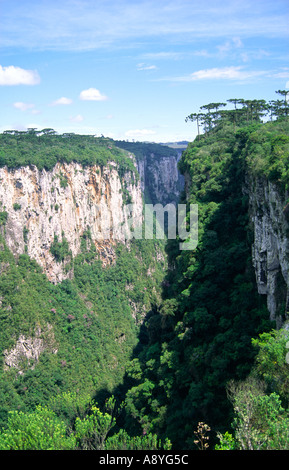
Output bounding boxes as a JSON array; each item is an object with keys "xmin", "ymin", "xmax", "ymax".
[{"xmin": 0, "ymin": 394, "xmax": 171, "ymax": 450}]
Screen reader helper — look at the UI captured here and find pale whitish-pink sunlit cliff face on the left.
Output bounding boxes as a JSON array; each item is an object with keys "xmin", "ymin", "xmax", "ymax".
[{"xmin": 0, "ymin": 162, "xmax": 143, "ymax": 282}]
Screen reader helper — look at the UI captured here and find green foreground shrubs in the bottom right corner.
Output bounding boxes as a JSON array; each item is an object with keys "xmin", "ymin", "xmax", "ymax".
[{"xmin": 216, "ymin": 329, "xmax": 289, "ymax": 450}]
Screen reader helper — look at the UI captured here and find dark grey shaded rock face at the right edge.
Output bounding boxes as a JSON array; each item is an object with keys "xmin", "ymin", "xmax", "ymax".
[{"xmin": 246, "ymin": 177, "xmax": 289, "ymax": 328}]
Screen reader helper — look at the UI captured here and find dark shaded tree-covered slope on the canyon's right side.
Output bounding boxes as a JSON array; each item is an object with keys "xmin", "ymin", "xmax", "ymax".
[{"xmin": 120, "ymin": 94, "xmax": 289, "ymax": 449}]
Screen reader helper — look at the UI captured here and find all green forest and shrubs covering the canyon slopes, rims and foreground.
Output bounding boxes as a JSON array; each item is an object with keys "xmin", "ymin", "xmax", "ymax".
[{"xmin": 0, "ymin": 90, "xmax": 289, "ymax": 450}]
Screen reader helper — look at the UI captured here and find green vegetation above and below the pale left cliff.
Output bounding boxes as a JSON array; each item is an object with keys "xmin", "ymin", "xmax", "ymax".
[{"xmin": 0, "ymin": 129, "xmax": 166, "ymax": 448}]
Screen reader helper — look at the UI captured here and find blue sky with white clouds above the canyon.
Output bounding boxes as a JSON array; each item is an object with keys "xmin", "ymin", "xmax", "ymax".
[{"xmin": 0, "ymin": 0, "xmax": 289, "ymax": 142}]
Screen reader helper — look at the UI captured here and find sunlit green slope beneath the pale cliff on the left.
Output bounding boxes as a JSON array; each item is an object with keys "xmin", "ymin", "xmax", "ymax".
[{"xmin": 0, "ymin": 222, "xmax": 165, "ymax": 438}]
